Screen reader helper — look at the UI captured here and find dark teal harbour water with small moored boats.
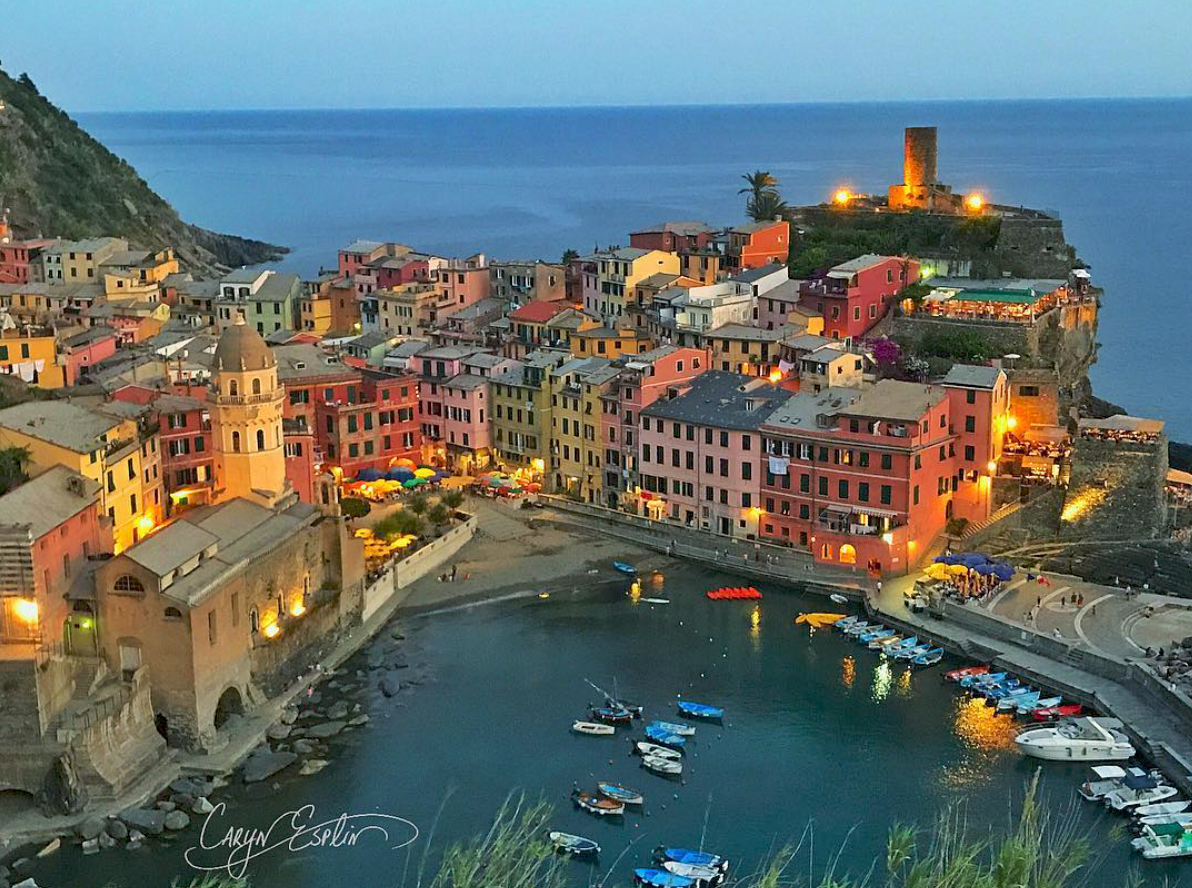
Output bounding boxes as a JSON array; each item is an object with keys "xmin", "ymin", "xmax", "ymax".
[{"xmin": 32, "ymin": 564, "xmax": 1172, "ymax": 888}]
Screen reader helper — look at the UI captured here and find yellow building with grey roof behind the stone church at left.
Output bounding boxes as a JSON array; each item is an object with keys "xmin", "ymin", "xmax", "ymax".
[{"xmin": 0, "ymin": 400, "xmax": 163, "ymax": 552}]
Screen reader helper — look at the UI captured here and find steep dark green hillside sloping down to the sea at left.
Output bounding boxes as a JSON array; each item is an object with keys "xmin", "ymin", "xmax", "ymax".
[{"xmin": 0, "ymin": 70, "xmax": 286, "ymax": 272}]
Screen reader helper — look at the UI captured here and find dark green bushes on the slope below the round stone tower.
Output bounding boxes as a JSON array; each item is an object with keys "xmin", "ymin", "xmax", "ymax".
[{"xmin": 790, "ymin": 207, "xmax": 1001, "ymax": 278}]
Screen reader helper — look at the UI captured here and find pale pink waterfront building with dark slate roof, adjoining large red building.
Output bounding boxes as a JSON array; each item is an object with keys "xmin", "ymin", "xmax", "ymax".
[{"xmin": 638, "ymin": 371, "xmax": 791, "ymax": 539}]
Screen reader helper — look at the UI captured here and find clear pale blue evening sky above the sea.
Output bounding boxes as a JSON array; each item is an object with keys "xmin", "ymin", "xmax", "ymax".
[{"xmin": 7, "ymin": 0, "xmax": 1192, "ymax": 112}]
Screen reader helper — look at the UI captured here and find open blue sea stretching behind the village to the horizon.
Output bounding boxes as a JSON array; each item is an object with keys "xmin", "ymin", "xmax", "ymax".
[{"xmin": 81, "ymin": 100, "xmax": 1192, "ymax": 439}]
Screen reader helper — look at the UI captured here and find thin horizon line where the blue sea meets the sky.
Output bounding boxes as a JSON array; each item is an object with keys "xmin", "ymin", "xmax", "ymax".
[{"xmin": 70, "ymin": 93, "xmax": 1192, "ymax": 114}]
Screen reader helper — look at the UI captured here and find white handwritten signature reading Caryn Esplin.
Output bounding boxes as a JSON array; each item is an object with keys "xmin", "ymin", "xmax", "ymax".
[{"xmin": 178, "ymin": 802, "xmax": 418, "ymax": 878}]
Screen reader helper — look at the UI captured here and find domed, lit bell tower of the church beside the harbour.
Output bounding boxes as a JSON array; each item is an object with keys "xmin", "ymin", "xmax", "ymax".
[{"xmin": 211, "ymin": 315, "xmax": 291, "ymax": 508}]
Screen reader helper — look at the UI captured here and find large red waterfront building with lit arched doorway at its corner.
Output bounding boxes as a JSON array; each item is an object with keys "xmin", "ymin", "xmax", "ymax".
[{"xmin": 759, "ymin": 368, "xmax": 1007, "ymax": 576}]
